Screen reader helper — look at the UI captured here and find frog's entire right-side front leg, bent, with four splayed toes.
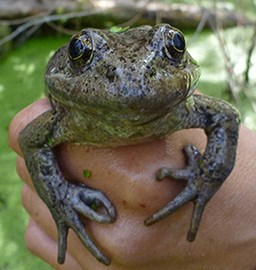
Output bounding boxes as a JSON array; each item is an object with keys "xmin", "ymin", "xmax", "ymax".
[{"xmin": 145, "ymin": 95, "xmax": 240, "ymax": 241}]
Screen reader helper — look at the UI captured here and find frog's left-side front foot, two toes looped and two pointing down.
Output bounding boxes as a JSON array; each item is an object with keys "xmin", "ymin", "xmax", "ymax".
[{"xmin": 51, "ymin": 182, "xmax": 116, "ymax": 265}]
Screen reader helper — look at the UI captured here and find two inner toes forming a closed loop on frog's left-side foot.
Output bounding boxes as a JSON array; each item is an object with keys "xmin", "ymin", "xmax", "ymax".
[{"xmin": 71, "ymin": 186, "xmax": 116, "ymax": 223}]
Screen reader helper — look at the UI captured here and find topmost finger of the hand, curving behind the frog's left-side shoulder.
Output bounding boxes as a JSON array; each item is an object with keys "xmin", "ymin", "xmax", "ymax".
[{"xmin": 9, "ymin": 98, "xmax": 51, "ymax": 155}]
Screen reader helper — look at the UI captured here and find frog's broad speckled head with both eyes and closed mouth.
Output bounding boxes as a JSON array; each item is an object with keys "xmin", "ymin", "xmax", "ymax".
[{"xmin": 46, "ymin": 24, "xmax": 200, "ymax": 122}]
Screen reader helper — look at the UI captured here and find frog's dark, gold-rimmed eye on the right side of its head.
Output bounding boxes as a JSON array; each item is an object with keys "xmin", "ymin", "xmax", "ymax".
[{"xmin": 165, "ymin": 30, "xmax": 186, "ymax": 60}]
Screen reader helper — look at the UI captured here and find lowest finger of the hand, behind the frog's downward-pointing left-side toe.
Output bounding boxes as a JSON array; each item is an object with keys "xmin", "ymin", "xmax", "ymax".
[{"xmin": 25, "ymin": 219, "xmax": 82, "ymax": 270}]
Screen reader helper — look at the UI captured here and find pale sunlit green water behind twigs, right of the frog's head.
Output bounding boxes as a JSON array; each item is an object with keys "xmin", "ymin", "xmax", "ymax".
[{"xmin": 188, "ymin": 27, "xmax": 256, "ymax": 130}]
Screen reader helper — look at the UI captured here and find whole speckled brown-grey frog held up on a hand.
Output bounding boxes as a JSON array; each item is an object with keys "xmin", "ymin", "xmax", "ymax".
[{"xmin": 19, "ymin": 24, "xmax": 239, "ymax": 265}]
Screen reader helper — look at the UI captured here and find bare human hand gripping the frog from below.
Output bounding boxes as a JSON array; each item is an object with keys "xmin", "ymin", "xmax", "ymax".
[{"xmin": 9, "ymin": 99, "xmax": 256, "ymax": 270}]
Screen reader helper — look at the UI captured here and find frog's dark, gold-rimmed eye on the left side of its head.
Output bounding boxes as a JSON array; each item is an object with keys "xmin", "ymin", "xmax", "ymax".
[{"xmin": 68, "ymin": 31, "xmax": 93, "ymax": 63}]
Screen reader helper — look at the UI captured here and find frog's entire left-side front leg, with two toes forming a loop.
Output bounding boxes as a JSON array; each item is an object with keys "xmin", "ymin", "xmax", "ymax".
[{"xmin": 19, "ymin": 110, "xmax": 116, "ymax": 265}]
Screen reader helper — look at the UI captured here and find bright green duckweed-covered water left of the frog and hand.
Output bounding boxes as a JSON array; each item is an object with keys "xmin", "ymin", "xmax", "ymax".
[{"xmin": 0, "ymin": 37, "xmax": 67, "ymax": 270}]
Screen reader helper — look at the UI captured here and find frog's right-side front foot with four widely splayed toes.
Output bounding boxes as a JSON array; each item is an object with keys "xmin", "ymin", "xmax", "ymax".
[{"xmin": 145, "ymin": 145, "xmax": 221, "ymax": 242}]
